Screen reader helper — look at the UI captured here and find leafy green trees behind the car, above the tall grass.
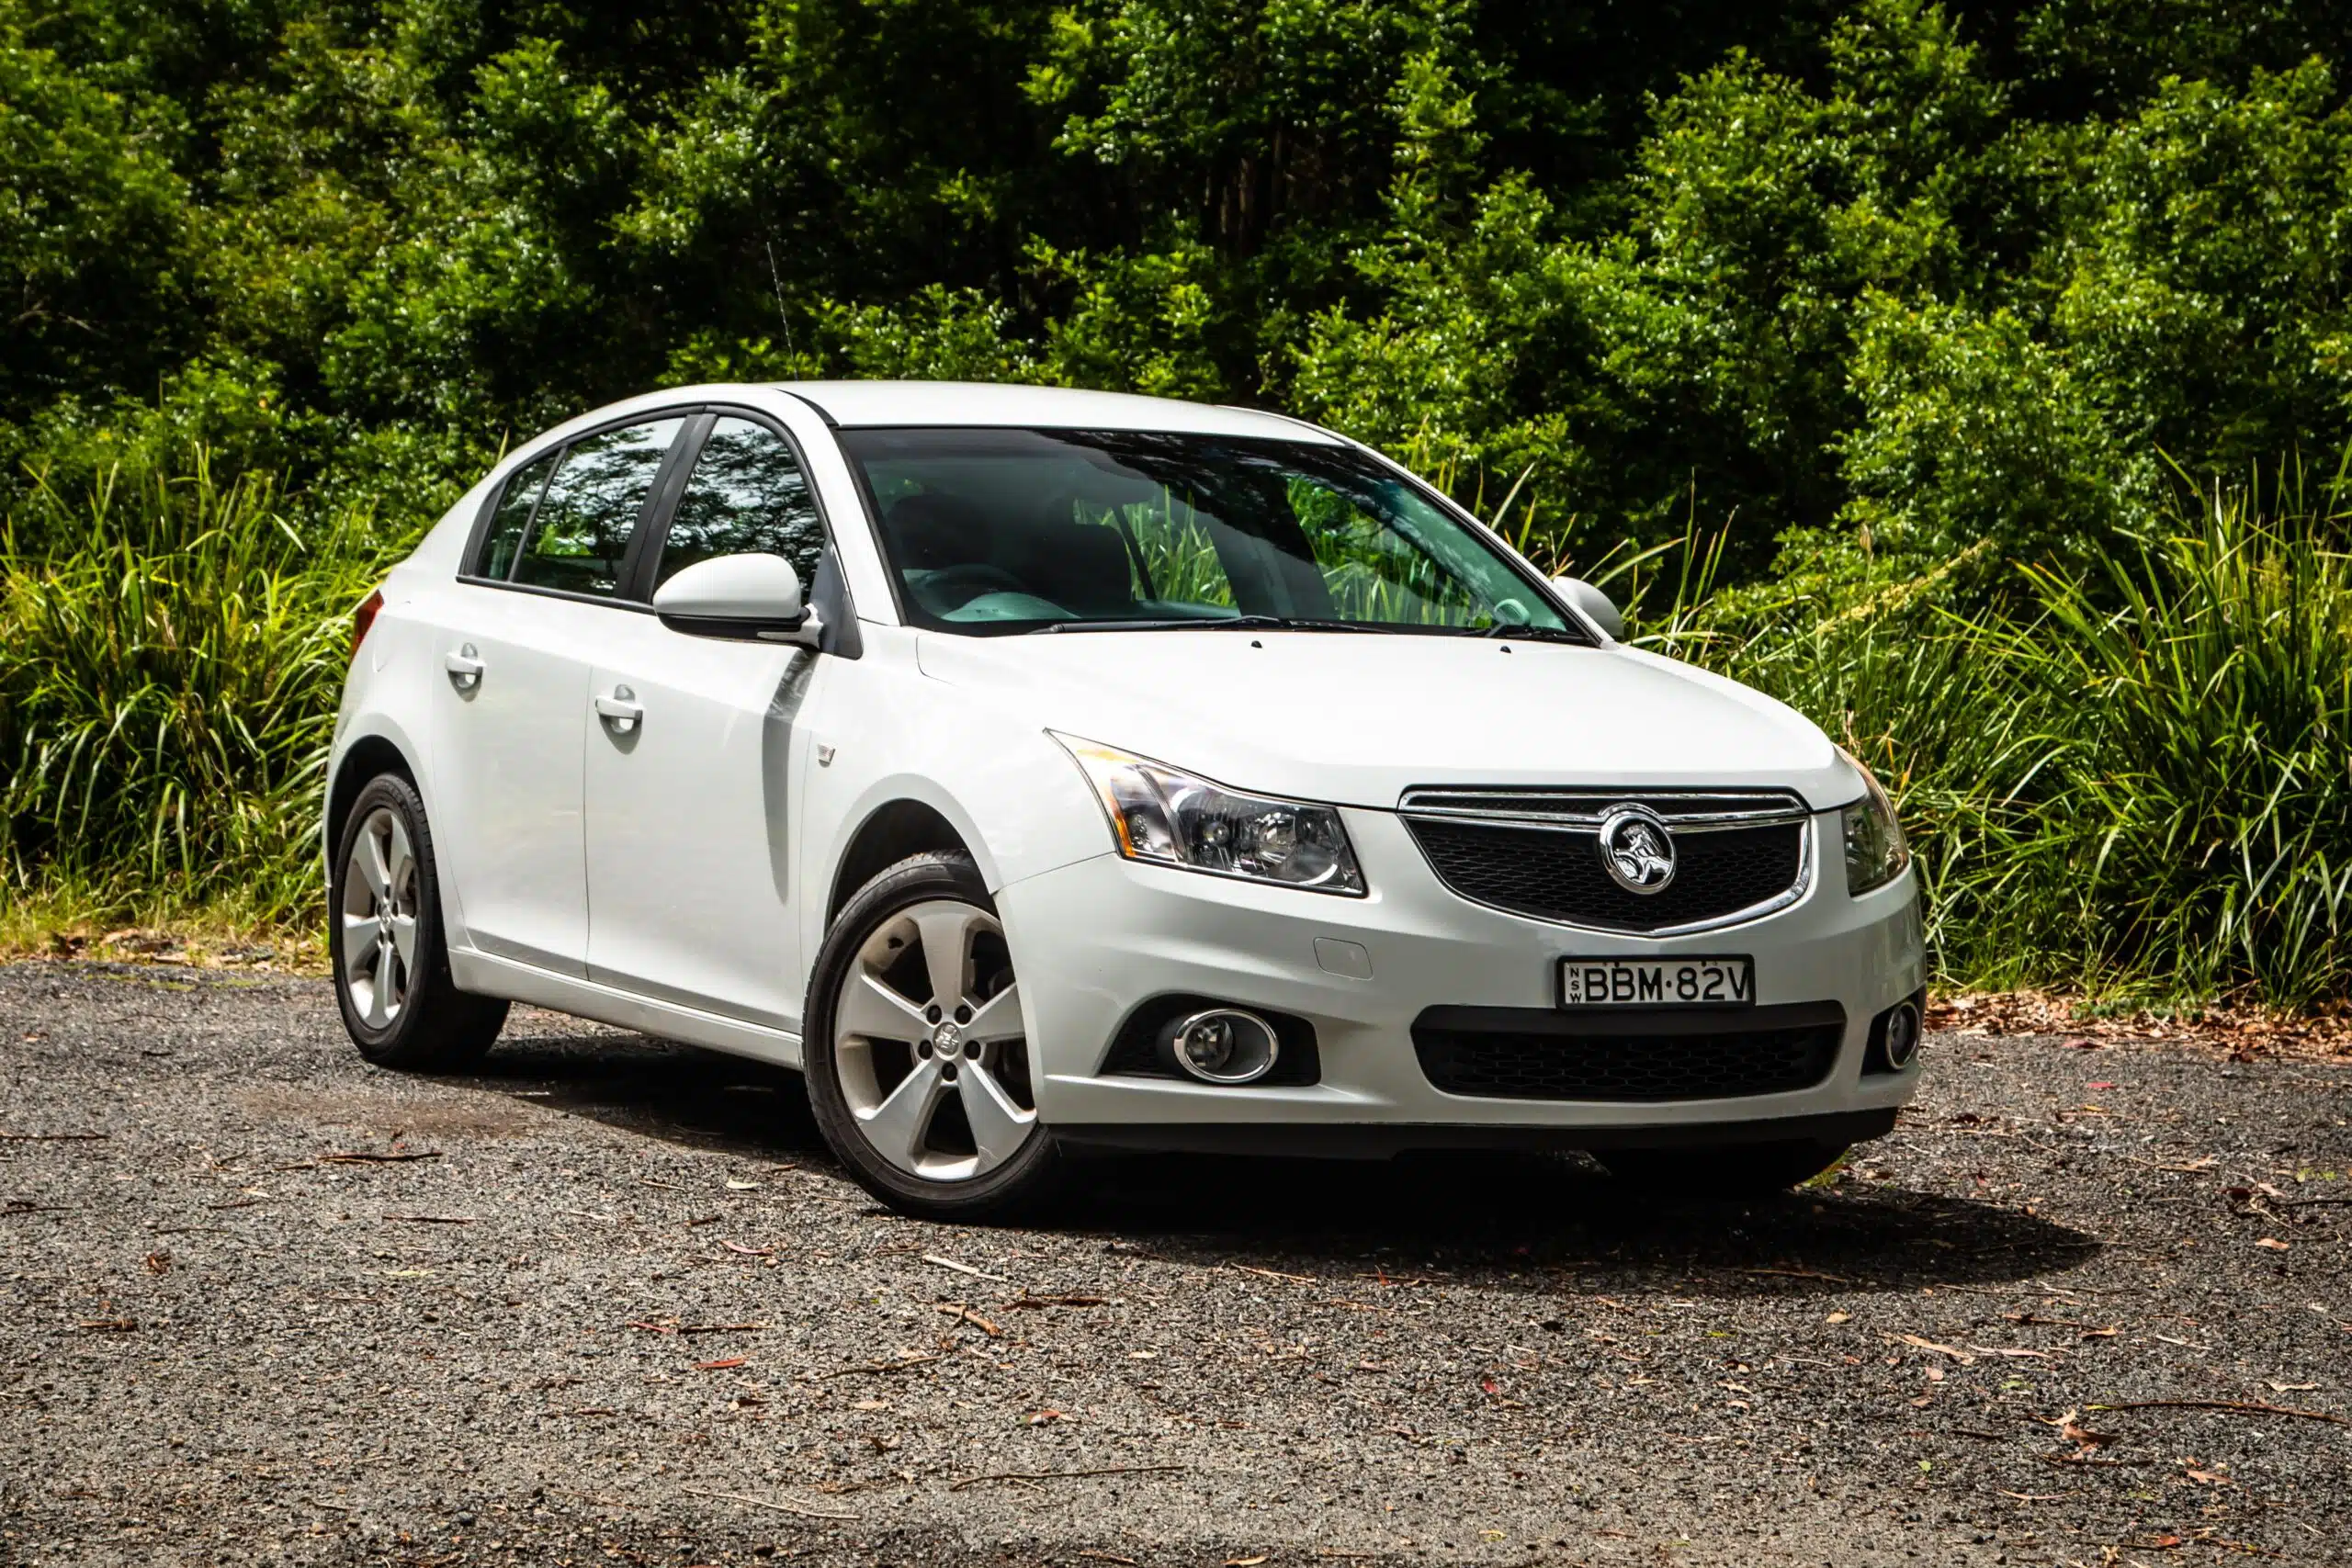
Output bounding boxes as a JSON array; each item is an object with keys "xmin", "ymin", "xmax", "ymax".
[{"xmin": 14, "ymin": 0, "xmax": 2352, "ymax": 573}]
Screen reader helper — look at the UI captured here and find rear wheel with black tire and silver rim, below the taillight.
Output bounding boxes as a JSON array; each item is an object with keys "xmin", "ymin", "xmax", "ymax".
[{"xmin": 327, "ymin": 773, "xmax": 505, "ymax": 1072}]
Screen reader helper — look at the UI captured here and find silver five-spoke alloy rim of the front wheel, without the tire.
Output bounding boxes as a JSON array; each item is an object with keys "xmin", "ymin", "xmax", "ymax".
[{"xmin": 832, "ymin": 898, "xmax": 1037, "ymax": 1182}]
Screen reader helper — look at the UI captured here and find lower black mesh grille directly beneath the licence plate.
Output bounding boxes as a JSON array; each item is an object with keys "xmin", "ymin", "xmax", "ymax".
[{"xmin": 1414, "ymin": 1001, "xmax": 1847, "ymax": 1102}]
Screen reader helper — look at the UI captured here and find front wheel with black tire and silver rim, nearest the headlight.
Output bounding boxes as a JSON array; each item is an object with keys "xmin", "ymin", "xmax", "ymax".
[{"xmin": 802, "ymin": 853, "xmax": 1061, "ymax": 1220}]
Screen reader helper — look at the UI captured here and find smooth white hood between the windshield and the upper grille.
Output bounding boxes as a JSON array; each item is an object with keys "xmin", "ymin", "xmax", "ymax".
[{"xmin": 917, "ymin": 630, "xmax": 1860, "ymax": 808}]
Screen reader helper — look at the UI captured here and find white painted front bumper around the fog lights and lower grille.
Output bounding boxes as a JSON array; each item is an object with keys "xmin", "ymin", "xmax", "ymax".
[{"xmin": 997, "ymin": 808, "xmax": 1924, "ymax": 1155}]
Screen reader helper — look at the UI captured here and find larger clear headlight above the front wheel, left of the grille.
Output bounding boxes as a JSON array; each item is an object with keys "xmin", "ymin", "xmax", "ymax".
[{"xmin": 1054, "ymin": 733, "xmax": 1364, "ymax": 896}]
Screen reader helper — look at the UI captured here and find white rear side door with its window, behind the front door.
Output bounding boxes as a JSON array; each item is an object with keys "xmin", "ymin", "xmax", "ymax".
[{"xmin": 433, "ymin": 416, "xmax": 687, "ymax": 976}]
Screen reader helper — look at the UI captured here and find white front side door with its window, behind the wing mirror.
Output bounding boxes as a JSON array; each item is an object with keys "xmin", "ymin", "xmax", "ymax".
[{"xmin": 588, "ymin": 412, "xmax": 854, "ymax": 1030}]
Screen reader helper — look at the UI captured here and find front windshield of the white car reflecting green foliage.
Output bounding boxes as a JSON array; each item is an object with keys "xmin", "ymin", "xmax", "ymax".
[{"xmin": 840, "ymin": 428, "xmax": 1588, "ymax": 642}]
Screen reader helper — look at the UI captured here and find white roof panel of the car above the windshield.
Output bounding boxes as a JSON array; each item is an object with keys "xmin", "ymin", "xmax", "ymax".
[{"xmin": 776, "ymin": 381, "xmax": 1340, "ymax": 446}]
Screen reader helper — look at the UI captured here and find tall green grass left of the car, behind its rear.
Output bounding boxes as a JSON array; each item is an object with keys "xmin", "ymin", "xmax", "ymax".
[{"xmin": 0, "ymin": 456, "xmax": 386, "ymax": 921}]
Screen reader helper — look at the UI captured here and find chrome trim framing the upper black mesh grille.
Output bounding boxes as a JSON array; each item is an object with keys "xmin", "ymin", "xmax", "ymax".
[{"xmin": 1397, "ymin": 785, "xmax": 1837, "ymax": 941}]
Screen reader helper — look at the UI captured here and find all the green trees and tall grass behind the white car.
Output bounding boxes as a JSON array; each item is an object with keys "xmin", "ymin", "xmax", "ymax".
[{"xmin": 0, "ymin": 0, "xmax": 2352, "ymax": 999}]
